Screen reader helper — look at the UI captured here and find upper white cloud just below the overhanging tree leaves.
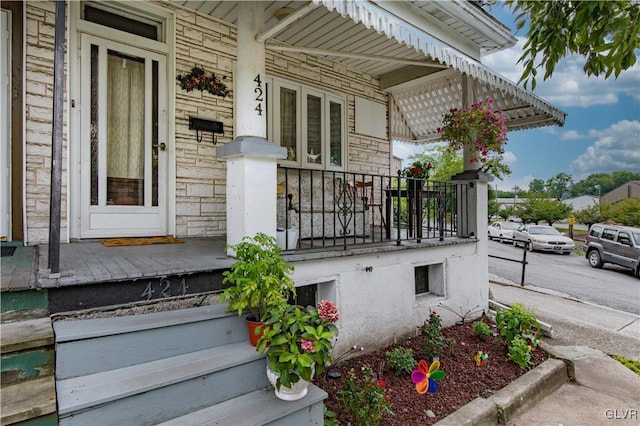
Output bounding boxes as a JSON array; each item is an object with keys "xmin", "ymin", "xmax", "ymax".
[{"xmin": 482, "ymin": 37, "xmax": 640, "ymax": 108}]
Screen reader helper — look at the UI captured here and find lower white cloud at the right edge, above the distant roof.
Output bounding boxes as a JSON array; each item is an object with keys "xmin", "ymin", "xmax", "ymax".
[{"xmin": 571, "ymin": 120, "xmax": 640, "ymax": 180}]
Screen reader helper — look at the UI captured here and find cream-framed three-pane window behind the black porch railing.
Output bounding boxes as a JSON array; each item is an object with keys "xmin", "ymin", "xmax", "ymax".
[{"xmin": 267, "ymin": 78, "xmax": 346, "ymax": 170}]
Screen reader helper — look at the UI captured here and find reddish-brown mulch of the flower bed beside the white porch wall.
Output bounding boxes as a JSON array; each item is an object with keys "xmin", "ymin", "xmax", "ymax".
[{"xmin": 314, "ymin": 324, "xmax": 548, "ymax": 426}]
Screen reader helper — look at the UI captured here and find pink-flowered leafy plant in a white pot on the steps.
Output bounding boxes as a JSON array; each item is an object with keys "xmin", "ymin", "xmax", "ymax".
[{"xmin": 257, "ymin": 300, "xmax": 339, "ymax": 401}]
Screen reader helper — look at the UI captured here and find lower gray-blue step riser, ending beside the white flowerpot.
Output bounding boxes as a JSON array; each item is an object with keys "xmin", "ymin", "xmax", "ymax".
[{"xmin": 60, "ymin": 359, "xmax": 269, "ymax": 426}]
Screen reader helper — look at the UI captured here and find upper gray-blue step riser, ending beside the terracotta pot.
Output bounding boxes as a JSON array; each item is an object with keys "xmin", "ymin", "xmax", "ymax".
[{"xmin": 54, "ymin": 313, "xmax": 248, "ymax": 379}]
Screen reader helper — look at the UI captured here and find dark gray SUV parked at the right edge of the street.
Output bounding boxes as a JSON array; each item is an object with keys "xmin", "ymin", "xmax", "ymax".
[{"xmin": 583, "ymin": 223, "xmax": 640, "ymax": 278}]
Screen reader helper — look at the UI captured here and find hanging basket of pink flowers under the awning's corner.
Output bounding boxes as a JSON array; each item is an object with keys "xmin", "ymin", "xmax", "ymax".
[{"xmin": 438, "ymin": 98, "xmax": 507, "ymax": 163}]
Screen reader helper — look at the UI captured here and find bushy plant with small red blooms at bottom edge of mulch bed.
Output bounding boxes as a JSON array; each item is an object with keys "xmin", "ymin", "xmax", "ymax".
[{"xmin": 337, "ymin": 365, "xmax": 391, "ymax": 426}]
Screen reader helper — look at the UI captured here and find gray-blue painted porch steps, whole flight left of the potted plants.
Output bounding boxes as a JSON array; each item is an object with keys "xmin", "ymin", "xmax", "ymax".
[{"xmin": 54, "ymin": 305, "xmax": 326, "ymax": 425}]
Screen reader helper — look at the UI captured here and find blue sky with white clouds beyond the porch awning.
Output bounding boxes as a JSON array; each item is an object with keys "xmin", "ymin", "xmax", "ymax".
[{"xmin": 394, "ymin": 5, "xmax": 640, "ymax": 191}]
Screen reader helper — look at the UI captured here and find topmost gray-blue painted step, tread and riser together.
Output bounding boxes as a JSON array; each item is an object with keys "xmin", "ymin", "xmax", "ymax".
[{"xmin": 53, "ymin": 304, "xmax": 248, "ymax": 380}]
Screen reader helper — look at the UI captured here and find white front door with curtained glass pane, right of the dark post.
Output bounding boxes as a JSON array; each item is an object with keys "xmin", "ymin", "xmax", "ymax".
[{"xmin": 80, "ymin": 34, "xmax": 167, "ymax": 238}]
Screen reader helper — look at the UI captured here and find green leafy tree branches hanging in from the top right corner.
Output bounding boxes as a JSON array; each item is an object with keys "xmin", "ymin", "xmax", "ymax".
[{"xmin": 506, "ymin": 0, "xmax": 640, "ymax": 89}]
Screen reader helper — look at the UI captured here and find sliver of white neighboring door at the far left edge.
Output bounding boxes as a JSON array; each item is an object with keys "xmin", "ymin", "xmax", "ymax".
[{"xmin": 0, "ymin": 10, "xmax": 11, "ymax": 240}]
